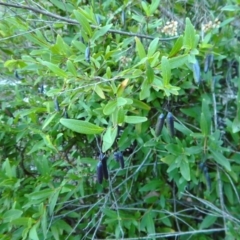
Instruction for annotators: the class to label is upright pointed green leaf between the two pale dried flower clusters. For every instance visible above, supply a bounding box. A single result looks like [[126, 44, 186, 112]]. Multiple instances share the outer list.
[[183, 18, 195, 50]]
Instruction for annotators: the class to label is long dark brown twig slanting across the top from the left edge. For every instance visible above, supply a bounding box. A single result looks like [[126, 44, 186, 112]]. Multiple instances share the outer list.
[[0, 2, 178, 41]]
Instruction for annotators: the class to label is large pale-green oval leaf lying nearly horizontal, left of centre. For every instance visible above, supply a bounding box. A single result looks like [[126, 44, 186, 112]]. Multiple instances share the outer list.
[[60, 118, 104, 134]]
